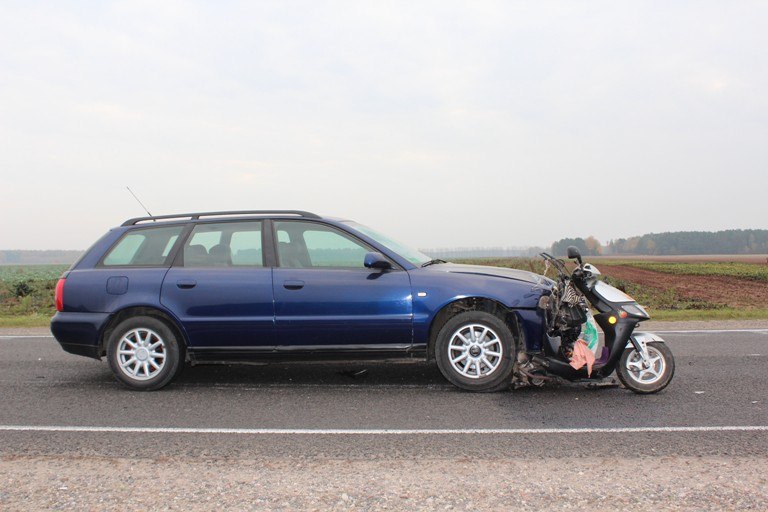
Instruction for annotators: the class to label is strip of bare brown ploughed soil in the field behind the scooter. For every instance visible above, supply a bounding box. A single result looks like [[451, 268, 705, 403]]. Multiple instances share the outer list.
[[599, 265, 768, 308]]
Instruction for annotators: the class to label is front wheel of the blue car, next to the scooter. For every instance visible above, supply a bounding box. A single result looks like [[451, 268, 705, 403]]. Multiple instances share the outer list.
[[435, 311, 516, 392]]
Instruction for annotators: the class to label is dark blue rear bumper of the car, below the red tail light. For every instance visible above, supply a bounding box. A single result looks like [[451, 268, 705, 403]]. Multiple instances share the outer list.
[[51, 312, 109, 359]]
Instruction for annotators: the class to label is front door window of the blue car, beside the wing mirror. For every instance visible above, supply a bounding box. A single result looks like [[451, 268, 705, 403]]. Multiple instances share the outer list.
[[275, 221, 371, 268]]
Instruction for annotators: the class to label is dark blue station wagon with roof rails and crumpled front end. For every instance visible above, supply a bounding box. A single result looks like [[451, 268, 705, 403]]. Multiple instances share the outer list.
[[51, 210, 553, 391]]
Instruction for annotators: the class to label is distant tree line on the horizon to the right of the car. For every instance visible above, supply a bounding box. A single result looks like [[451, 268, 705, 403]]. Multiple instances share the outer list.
[[552, 229, 768, 256]]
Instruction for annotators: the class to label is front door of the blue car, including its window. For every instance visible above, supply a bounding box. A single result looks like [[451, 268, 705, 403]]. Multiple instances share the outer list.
[[273, 220, 413, 351]]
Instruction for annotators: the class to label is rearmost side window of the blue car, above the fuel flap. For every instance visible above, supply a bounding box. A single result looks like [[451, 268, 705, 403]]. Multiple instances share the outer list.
[[101, 226, 183, 267]]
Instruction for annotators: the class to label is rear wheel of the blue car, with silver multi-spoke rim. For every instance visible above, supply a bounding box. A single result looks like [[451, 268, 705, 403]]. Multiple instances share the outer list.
[[107, 316, 184, 391]]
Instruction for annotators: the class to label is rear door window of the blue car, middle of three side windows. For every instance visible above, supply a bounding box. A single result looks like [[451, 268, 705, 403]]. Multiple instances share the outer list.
[[183, 221, 264, 267]]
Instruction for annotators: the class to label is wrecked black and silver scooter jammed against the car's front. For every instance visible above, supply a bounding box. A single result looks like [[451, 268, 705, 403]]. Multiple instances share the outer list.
[[515, 246, 675, 394]]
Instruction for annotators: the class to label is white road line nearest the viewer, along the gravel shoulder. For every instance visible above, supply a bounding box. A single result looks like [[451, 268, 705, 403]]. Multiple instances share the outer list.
[[0, 425, 768, 436]]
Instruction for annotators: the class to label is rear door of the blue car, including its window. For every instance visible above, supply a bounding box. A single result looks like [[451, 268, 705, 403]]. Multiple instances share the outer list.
[[160, 220, 275, 351]]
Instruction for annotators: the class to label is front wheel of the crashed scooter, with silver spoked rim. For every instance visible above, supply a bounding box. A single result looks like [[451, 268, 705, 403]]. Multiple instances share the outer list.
[[616, 341, 675, 395]]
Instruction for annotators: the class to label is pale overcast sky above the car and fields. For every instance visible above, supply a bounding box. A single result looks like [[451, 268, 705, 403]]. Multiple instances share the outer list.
[[0, 0, 768, 249]]
